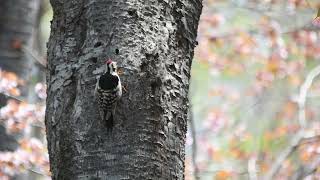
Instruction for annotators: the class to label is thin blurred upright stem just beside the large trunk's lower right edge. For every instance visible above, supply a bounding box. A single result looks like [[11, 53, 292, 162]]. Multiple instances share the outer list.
[[189, 107, 200, 180]]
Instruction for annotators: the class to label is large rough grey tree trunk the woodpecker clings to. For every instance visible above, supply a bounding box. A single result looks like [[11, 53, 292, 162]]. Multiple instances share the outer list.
[[46, 0, 202, 180]]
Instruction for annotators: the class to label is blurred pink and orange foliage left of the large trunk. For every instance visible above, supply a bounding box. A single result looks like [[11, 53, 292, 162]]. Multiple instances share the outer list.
[[0, 70, 50, 180]]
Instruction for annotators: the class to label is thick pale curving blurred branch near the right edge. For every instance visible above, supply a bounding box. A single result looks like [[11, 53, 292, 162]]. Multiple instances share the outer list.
[[265, 65, 320, 180]]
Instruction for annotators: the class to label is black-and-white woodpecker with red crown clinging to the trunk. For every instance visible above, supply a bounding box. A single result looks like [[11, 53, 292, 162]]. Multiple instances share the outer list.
[[94, 59, 122, 130]]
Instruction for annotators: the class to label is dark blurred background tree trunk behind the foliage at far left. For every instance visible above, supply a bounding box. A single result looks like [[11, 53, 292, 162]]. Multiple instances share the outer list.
[[0, 0, 40, 150]]
